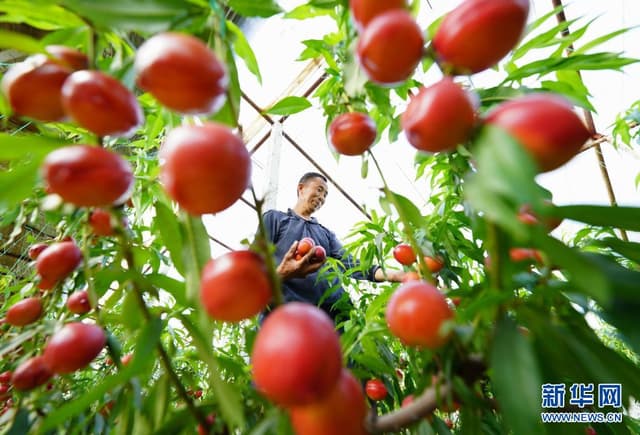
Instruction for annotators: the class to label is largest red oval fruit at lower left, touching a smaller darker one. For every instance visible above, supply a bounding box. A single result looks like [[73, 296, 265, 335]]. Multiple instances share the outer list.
[[43, 322, 107, 374]]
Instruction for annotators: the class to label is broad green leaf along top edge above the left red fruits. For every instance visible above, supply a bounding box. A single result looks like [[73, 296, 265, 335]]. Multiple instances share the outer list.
[[62, 0, 205, 33]]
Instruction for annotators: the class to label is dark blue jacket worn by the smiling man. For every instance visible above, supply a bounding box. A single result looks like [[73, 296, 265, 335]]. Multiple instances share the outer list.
[[263, 209, 378, 320]]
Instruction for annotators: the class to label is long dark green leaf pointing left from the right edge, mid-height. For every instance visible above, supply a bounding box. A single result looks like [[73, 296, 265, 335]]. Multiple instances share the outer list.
[[553, 205, 640, 231]]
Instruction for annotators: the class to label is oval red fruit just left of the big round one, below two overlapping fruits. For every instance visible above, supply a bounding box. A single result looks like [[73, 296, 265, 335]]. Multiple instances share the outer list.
[[42, 145, 134, 207]]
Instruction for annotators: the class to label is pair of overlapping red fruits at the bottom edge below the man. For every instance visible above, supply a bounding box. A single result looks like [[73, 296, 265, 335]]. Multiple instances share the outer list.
[[251, 302, 367, 435]]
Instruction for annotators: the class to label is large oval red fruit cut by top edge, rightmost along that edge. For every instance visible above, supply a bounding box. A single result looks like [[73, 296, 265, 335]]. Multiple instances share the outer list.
[[433, 0, 529, 74]]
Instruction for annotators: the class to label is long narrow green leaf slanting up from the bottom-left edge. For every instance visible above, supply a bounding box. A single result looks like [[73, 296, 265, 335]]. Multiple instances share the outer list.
[[40, 319, 162, 432]]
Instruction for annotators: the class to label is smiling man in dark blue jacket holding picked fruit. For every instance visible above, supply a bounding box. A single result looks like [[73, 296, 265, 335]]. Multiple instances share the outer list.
[[264, 172, 404, 323]]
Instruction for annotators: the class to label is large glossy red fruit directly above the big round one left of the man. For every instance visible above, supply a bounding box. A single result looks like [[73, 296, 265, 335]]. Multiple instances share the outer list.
[[134, 32, 229, 114]]
